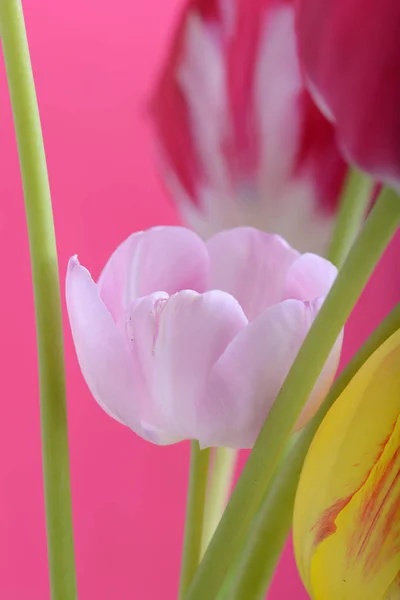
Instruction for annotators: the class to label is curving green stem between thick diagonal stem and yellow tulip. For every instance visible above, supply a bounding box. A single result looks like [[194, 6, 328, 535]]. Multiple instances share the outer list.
[[229, 304, 400, 600]]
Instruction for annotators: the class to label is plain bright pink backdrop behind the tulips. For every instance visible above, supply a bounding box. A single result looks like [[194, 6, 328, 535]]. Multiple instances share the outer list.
[[0, 0, 400, 600]]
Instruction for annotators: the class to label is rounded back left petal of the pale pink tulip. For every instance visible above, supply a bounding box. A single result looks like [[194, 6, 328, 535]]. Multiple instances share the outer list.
[[99, 227, 208, 320]]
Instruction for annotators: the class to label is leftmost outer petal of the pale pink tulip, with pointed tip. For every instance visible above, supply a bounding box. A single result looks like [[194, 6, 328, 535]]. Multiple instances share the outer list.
[[66, 257, 143, 435]]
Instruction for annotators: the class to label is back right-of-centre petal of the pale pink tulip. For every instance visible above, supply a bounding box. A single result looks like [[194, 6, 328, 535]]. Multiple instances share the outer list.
[[207, 227, 300, 321]]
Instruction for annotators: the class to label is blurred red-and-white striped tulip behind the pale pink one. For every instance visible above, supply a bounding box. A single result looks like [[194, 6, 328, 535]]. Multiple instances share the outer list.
[[152, 0, 346, 253]]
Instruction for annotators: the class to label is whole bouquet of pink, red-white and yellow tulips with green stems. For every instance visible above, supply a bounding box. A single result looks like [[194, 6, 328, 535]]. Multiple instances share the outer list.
[[0, 0, 400, 600]]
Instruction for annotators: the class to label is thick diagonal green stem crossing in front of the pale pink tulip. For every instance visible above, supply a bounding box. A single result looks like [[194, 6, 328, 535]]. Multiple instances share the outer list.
[[187, 190, 400, 600]]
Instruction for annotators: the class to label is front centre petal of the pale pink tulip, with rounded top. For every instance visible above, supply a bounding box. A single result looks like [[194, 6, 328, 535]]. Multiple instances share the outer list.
[[153, 291, 247, 439]]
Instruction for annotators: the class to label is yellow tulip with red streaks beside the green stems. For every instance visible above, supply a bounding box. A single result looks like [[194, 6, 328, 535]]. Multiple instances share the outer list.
[[294, 331, 400, 600]]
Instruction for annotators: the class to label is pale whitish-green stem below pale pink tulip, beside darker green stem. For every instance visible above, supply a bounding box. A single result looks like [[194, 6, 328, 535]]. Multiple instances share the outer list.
[[201, 448, 238, 556]]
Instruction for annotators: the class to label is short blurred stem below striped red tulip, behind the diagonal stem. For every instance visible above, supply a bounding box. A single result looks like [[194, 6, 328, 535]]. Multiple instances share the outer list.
[[328, 169, 376, 267]]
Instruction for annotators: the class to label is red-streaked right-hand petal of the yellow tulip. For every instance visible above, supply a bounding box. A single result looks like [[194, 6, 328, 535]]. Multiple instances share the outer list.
[[311, 419, 400, 600]]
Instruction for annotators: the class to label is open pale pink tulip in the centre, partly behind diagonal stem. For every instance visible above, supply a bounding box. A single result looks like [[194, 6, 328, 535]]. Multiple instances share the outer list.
[[66, 227, 341, 448]]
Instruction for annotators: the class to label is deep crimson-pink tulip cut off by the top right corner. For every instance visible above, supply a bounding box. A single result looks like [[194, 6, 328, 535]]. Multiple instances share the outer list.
[[298, 0, 400, 188]]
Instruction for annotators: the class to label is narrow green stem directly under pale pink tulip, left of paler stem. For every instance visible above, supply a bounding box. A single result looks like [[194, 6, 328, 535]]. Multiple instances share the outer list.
[[179, 441, 210, 599]]
